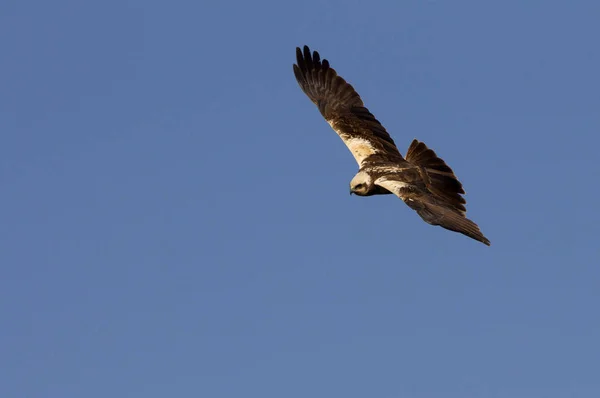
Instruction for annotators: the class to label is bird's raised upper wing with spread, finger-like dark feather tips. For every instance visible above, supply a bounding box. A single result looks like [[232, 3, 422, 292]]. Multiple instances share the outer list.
[[294, 46, 403, 167]]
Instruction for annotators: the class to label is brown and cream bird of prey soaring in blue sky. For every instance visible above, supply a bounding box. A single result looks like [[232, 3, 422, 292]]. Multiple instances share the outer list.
[[293, 46, 491, 246]]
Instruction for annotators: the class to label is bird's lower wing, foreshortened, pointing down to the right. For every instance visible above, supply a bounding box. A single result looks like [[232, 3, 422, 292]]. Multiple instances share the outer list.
[[375, 175, 490, 246]]
